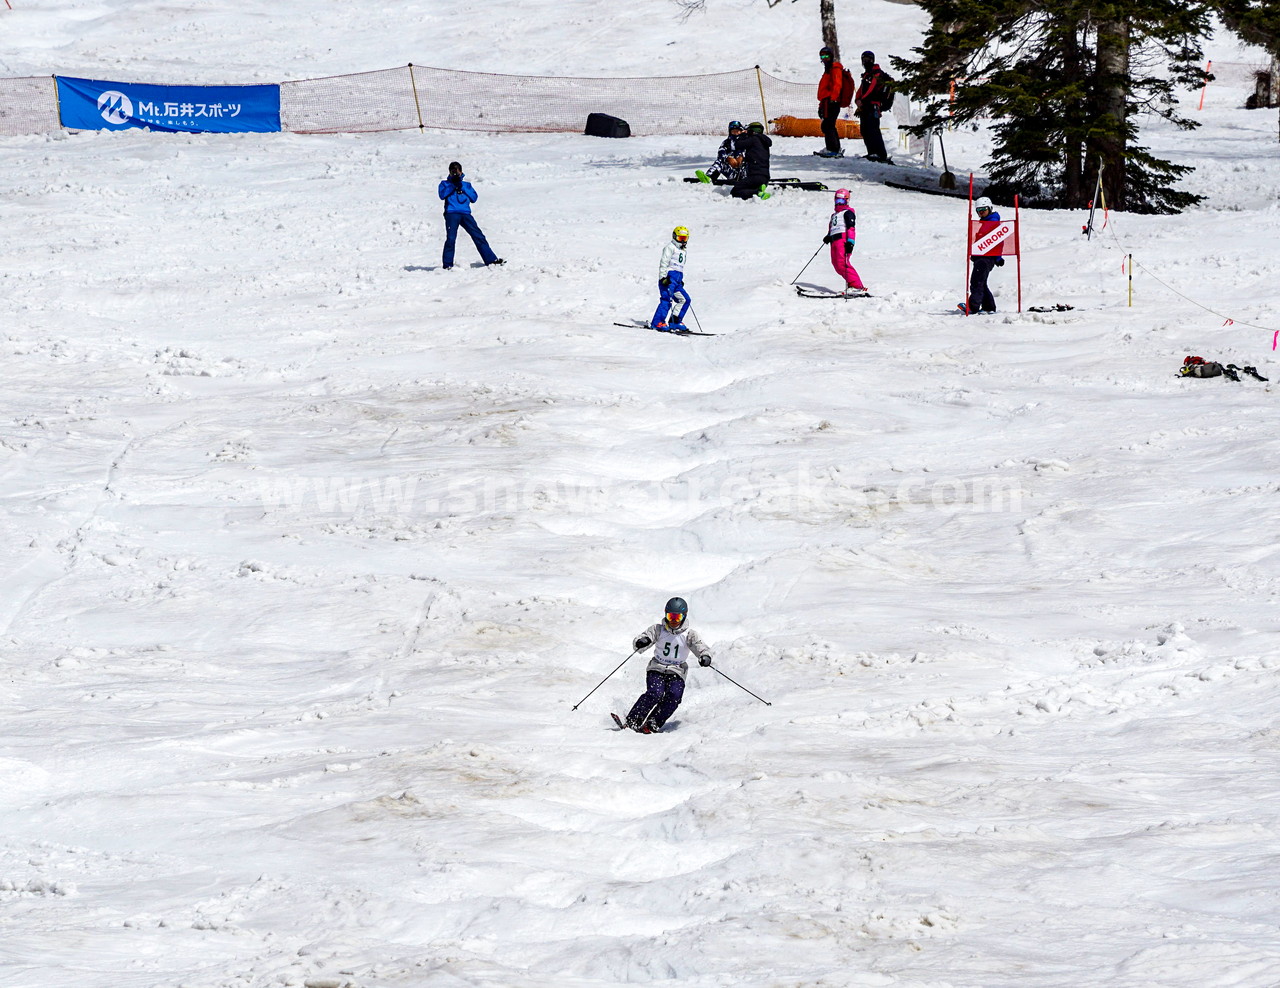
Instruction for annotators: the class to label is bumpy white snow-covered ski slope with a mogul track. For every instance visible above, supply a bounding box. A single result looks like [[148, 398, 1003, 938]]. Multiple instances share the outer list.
[[0, 0, 1280, 988]]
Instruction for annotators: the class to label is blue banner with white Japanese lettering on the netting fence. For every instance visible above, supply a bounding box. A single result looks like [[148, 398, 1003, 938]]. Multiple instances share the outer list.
[[56, 76, 280, 133]]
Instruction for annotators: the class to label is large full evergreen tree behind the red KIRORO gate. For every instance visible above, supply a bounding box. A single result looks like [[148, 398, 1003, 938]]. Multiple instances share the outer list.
[[893, 0, 1208, 212]]
